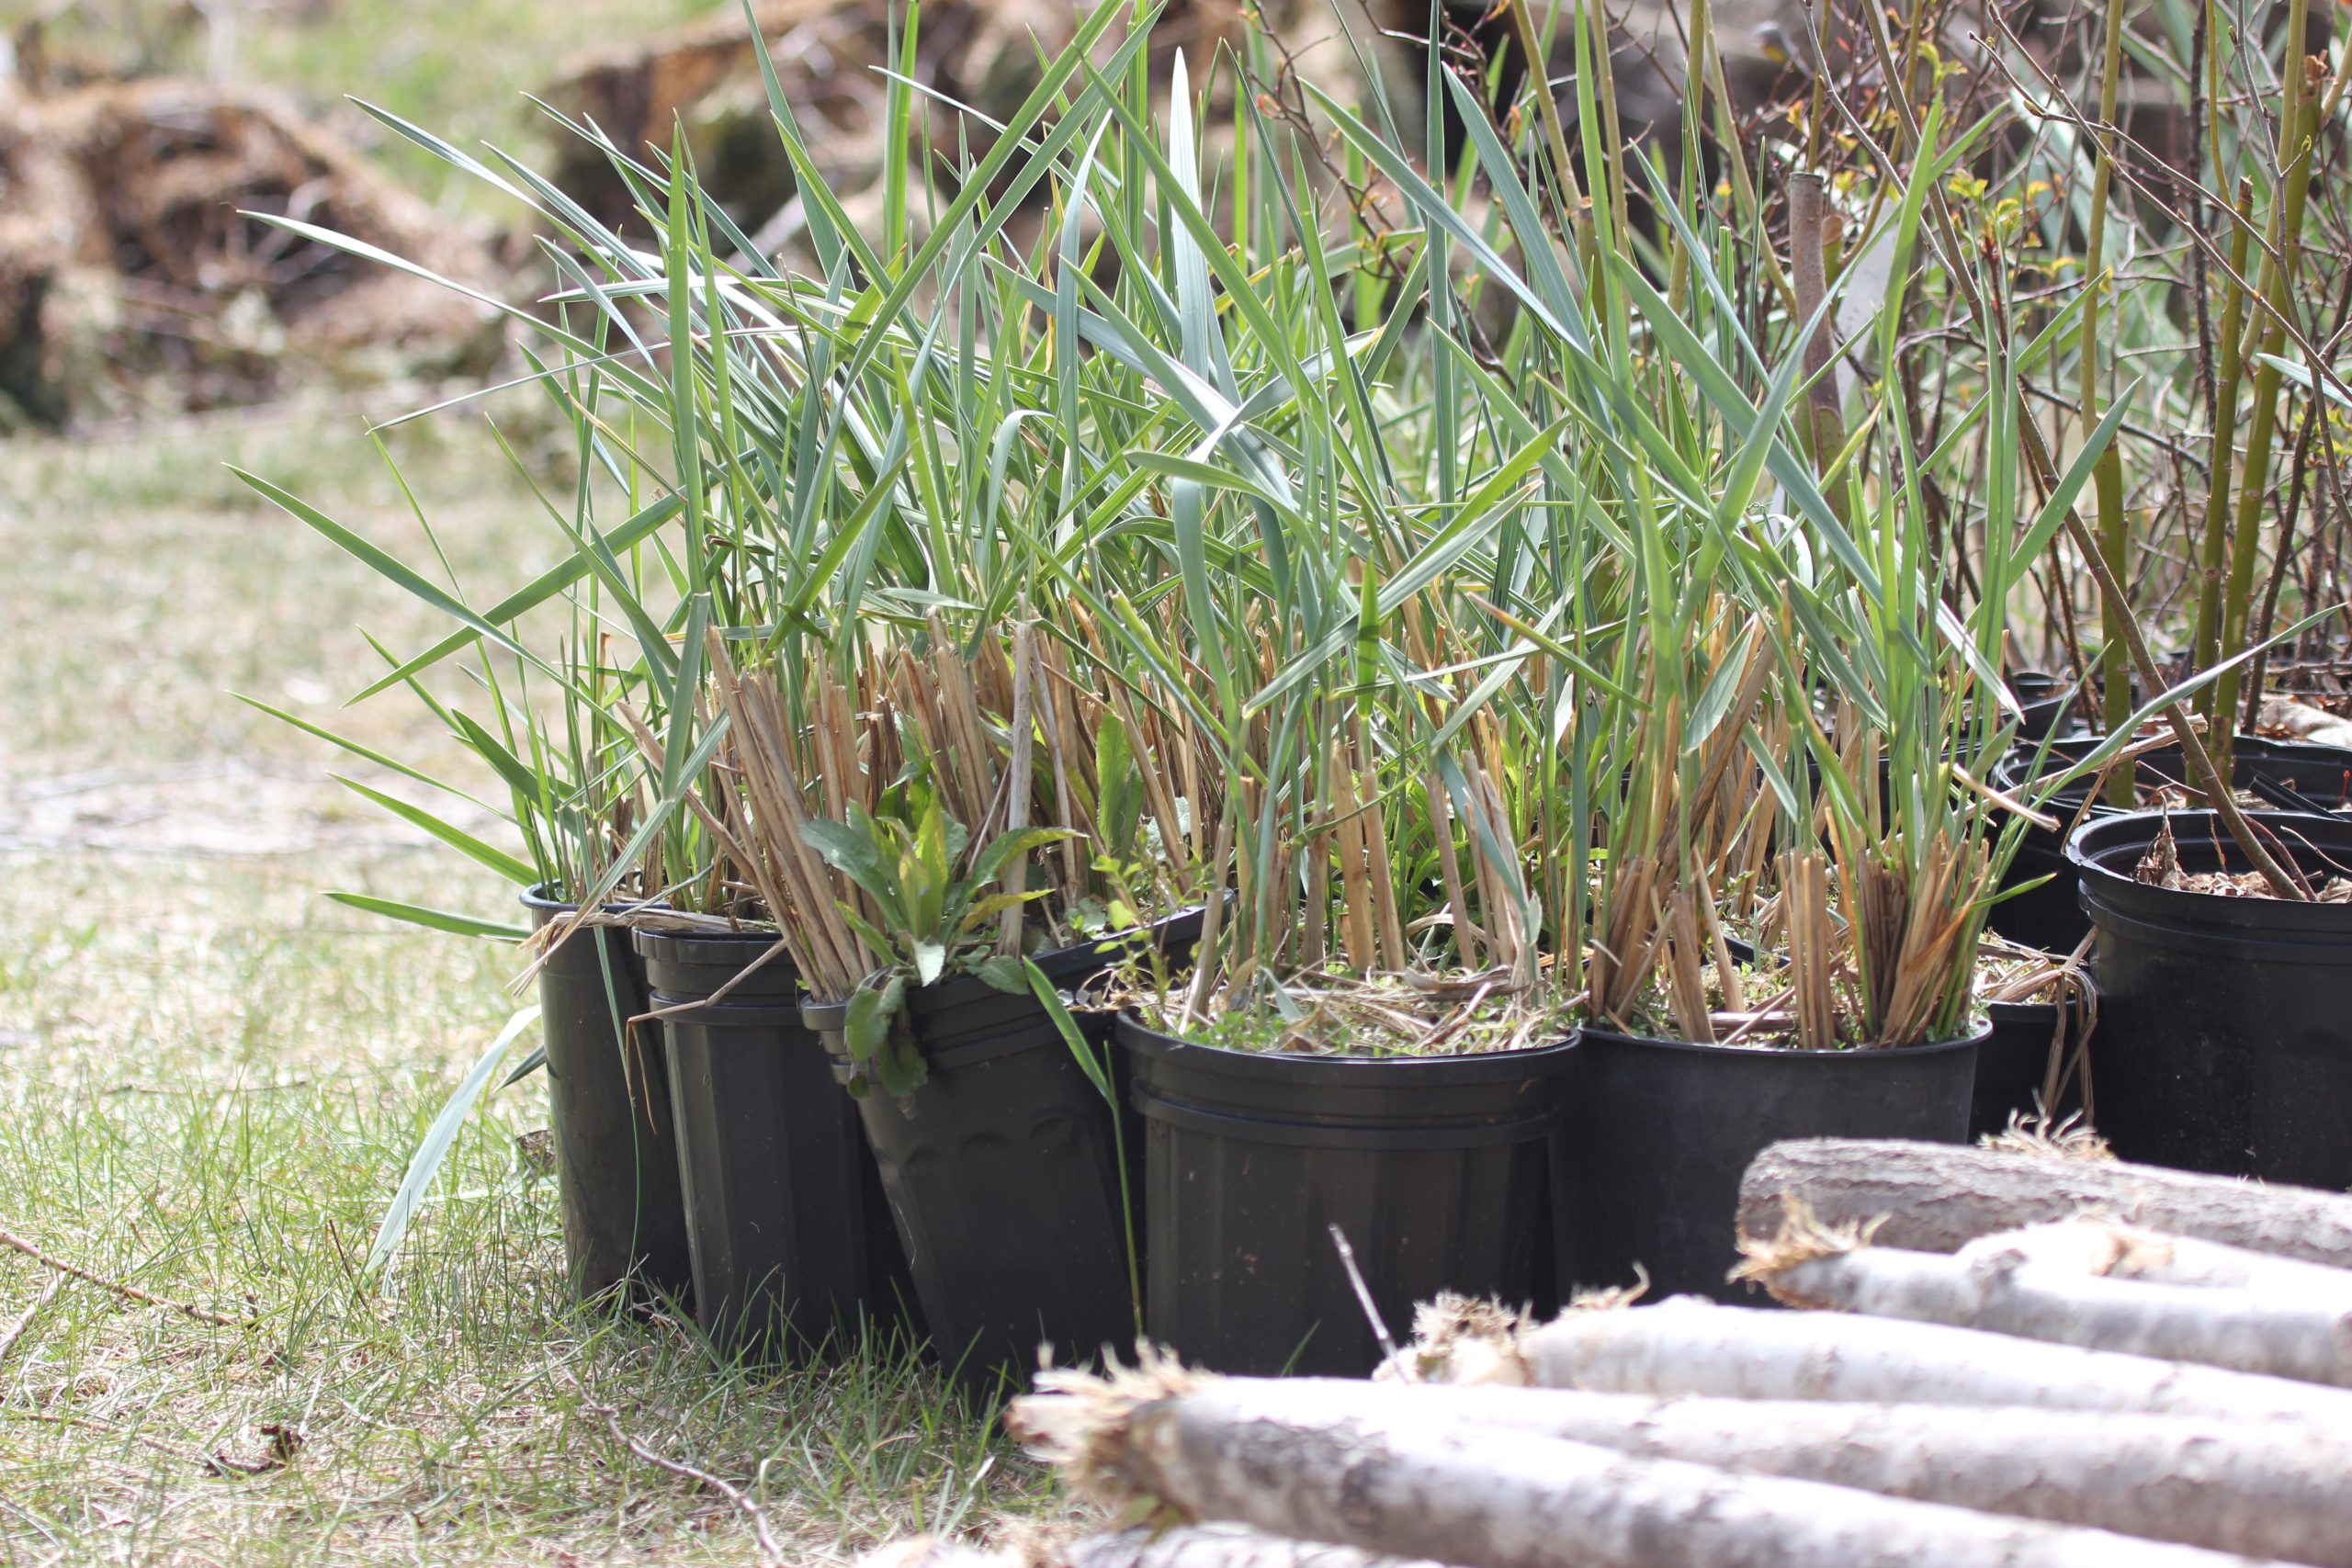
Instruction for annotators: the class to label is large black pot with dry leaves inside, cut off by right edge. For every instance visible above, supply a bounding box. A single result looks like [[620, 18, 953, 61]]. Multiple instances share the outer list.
[[2067, 811, 2352, 1192]]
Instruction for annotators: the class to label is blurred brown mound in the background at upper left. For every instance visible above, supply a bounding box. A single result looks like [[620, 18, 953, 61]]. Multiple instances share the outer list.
[[0, 77, 501, 428]]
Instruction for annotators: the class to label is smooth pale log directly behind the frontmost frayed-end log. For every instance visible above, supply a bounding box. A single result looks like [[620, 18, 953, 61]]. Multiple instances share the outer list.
[[1185, 1382, 2352, 1568]]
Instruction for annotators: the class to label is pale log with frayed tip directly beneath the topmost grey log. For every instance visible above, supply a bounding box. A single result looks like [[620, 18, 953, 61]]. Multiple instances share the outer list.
[[1750, 1246, 2352, 1387]]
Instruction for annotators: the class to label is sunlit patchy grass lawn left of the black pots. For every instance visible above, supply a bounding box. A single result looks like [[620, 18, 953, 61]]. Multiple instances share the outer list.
[[0, 400, 1061, 1563]]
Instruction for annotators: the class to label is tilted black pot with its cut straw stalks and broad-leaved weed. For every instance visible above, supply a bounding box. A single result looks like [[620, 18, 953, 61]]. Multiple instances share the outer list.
[[718, 621, 1166, 1387]]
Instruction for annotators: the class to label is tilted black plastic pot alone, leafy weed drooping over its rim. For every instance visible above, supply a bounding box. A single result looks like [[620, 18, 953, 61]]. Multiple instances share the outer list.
[[802, 919, 1157, 1389]]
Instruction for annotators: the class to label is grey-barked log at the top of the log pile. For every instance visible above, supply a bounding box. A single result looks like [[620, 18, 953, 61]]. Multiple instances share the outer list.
[[1740, 1138, 2352, 1269]]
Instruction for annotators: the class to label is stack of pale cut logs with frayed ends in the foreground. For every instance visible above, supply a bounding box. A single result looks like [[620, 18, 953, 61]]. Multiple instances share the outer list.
[[868, 1138, 2352, 1568]]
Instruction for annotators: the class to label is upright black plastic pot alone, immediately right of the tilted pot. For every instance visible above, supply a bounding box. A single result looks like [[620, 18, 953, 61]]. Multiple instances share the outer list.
[[1117, 1016, 1574, 1378]]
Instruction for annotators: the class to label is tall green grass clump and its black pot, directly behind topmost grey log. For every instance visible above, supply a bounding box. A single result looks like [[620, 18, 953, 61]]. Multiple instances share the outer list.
[[1345, 49, 2112, 1295]]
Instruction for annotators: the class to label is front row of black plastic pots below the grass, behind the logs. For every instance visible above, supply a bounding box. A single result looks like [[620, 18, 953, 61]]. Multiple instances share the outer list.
[[529, 893, 2098, 1384]]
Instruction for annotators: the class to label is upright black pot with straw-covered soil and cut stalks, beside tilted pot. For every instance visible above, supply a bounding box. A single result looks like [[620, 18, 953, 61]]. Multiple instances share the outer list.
[[1120, 662, 1571, 1375]]
